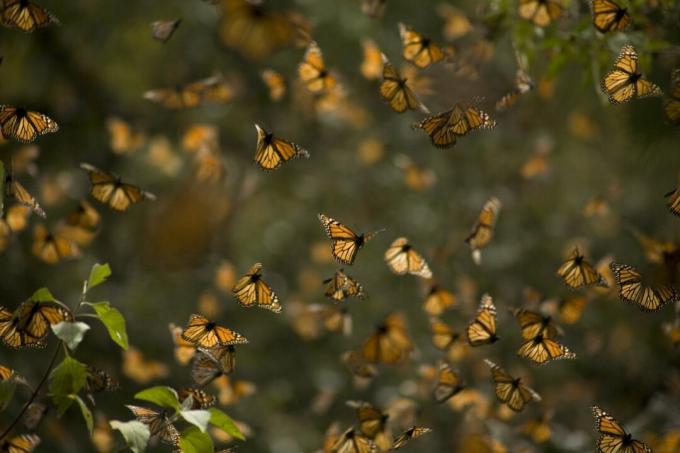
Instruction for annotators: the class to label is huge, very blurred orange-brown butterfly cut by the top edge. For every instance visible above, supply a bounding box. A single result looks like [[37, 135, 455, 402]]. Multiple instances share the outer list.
[[219, 0, 295, 59]]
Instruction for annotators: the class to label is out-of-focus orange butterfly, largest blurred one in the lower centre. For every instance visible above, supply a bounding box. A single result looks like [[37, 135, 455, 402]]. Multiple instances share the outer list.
[[361, 313, 413, 364]]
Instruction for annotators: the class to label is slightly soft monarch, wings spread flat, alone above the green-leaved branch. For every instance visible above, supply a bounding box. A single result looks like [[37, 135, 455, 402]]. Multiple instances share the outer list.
[[80, 163, 156, 212]]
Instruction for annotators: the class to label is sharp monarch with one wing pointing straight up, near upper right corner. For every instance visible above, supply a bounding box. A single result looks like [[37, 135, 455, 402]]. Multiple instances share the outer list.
[[602, 45, 663, 104]]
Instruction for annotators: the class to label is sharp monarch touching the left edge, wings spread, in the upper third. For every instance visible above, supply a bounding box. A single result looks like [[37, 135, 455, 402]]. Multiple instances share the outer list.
[[0, 104, 59, 143]]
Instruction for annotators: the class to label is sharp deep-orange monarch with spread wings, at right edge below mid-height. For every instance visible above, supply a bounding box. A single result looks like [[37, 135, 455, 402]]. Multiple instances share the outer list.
[[609, 262, 680, 311]]
